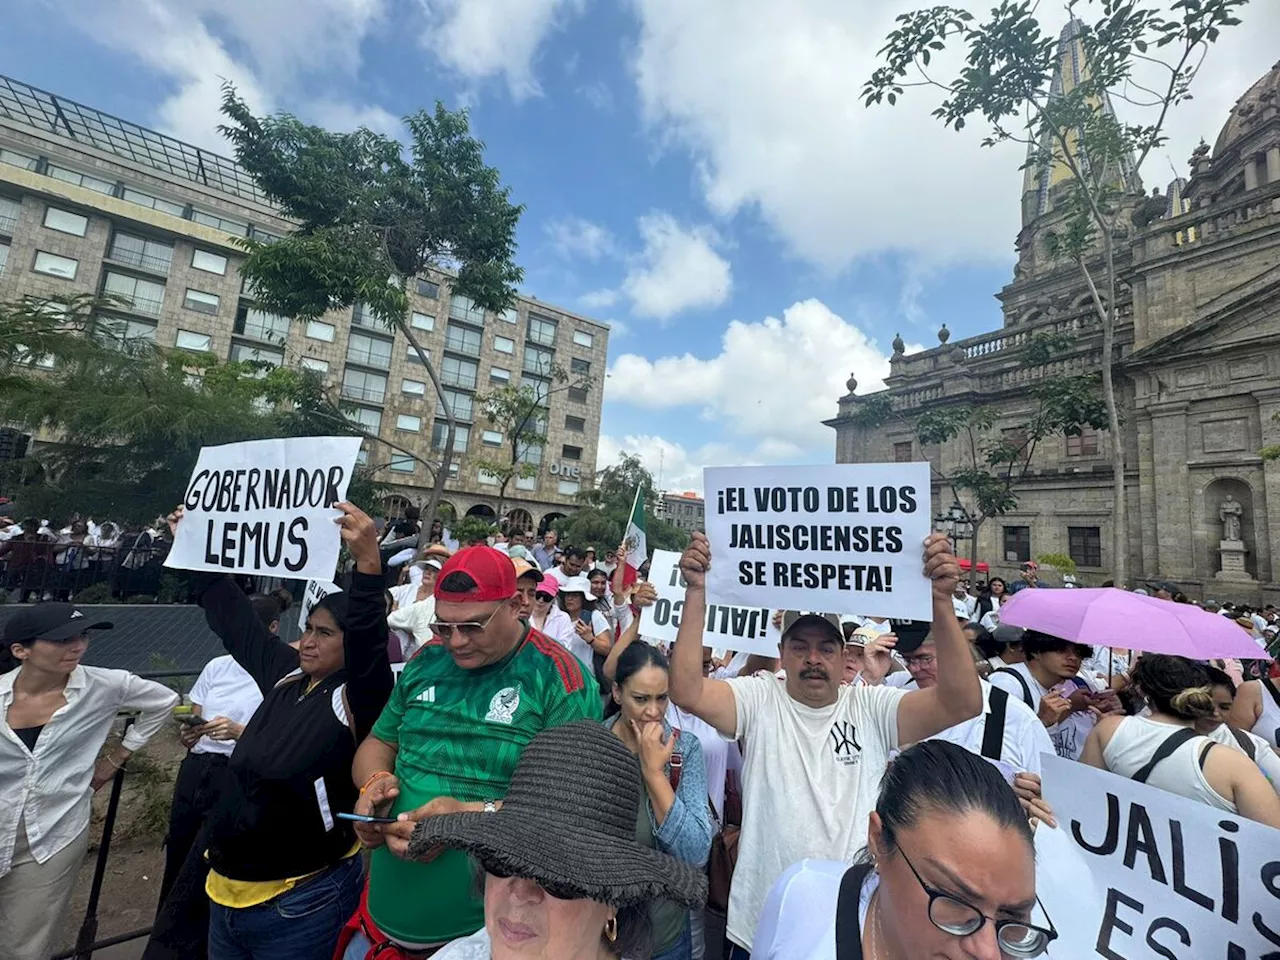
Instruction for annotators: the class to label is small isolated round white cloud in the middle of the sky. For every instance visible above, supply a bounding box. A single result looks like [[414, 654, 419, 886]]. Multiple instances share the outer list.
[[622, 212, 733, 320]]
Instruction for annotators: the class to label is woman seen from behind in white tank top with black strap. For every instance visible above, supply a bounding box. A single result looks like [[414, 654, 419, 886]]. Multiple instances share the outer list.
[[1080, 653, 1280, 828]]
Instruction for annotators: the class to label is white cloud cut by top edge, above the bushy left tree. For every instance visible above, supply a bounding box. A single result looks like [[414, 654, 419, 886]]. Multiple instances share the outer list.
[[419, 0, 585, 100]]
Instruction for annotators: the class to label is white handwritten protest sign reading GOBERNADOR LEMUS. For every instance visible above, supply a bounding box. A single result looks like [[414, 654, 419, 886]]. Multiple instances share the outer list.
[[165, 436, 361, 580]]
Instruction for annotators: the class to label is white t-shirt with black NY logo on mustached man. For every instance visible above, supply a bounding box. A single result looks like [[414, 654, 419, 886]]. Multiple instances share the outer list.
[[724, 675, 906, 950]]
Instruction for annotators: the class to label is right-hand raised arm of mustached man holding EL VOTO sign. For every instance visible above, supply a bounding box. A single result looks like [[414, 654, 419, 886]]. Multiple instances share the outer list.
[[897, 534, 982, 744]]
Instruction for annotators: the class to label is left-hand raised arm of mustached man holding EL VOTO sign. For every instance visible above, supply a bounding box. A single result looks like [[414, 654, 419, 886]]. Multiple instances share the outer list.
[[671, 532, 737, 737]]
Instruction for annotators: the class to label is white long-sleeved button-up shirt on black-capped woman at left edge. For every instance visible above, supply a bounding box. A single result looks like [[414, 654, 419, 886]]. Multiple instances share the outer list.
[[0, 667, 178, 877]]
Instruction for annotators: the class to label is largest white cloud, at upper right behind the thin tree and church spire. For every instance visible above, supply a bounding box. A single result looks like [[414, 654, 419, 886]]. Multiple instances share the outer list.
[[632, 0, 1280, 269]]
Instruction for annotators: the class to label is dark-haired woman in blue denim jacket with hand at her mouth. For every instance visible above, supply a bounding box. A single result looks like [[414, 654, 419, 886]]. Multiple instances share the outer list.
[[604, 642, 712, 960]]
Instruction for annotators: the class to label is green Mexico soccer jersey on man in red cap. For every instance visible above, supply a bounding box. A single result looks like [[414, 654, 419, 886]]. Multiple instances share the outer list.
[[369, 628, 600, 945]]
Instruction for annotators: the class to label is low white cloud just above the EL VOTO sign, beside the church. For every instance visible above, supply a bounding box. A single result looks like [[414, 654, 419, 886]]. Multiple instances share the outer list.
[[605, 300, 906, 461]]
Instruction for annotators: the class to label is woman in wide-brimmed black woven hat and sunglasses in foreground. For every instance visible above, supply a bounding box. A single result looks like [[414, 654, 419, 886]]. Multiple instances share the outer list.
[[410, 721, 707, 960]]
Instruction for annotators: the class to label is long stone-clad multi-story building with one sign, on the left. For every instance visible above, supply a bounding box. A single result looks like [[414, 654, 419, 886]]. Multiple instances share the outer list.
[[0, 77, 609, 542]]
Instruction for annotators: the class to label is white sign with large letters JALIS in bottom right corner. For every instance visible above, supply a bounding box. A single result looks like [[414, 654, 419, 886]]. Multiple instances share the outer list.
[[1037, 757, 1280, 960]]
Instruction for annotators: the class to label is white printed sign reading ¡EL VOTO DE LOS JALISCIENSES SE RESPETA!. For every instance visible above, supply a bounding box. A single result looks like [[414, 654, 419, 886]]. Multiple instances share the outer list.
[[704, 463, 933, 620]]
